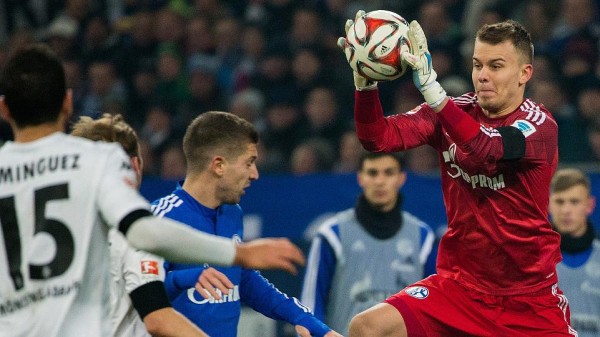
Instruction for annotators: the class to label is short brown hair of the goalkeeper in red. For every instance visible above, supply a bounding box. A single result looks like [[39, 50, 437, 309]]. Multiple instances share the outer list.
[[475, 20, 533, 63]]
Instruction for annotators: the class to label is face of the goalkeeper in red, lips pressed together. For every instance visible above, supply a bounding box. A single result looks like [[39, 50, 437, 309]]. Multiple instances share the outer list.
[[471, 40, 533, 117]]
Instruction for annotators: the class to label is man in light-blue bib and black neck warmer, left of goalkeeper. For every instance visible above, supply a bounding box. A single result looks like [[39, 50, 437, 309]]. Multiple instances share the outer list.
[[301, 152, 437, 335]]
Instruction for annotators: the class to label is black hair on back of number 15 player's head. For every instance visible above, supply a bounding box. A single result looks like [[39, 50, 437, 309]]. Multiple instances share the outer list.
[[0, 44, 67, 128]]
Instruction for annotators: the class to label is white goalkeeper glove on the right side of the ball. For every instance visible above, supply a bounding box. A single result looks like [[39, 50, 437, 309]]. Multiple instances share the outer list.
[[401, 20, 447, 108]]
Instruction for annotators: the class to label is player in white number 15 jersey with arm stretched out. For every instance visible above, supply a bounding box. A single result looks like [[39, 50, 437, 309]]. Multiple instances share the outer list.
[[0, 45, 303, 337]]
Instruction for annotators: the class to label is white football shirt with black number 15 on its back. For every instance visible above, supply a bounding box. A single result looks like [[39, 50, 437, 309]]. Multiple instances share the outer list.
[[0, 132, 149, 337]]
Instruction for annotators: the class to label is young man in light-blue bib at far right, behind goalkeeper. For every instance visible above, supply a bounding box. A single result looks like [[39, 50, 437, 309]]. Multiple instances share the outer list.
[[549, 168, 600, 337]]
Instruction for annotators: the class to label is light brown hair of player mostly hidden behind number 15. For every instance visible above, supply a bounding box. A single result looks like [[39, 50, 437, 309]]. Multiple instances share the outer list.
[[71, 113, 140, 158]]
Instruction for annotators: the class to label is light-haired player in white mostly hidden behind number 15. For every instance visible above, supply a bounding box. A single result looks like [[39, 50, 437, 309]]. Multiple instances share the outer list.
[[71, 114, 218, 337]]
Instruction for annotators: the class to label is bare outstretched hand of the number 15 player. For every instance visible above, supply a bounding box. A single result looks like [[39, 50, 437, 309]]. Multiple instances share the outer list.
[[234, 238, 305, 275]]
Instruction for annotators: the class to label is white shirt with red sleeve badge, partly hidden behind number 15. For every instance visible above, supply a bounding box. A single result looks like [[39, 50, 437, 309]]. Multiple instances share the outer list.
[[108, 229, 165, 337]]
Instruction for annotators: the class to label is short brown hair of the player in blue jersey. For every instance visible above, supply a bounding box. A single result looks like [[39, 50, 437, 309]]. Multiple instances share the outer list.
[[183, 111, 258, 172]]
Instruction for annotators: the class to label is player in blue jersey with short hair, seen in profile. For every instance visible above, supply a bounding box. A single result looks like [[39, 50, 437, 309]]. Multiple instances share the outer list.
[[152, 111, 341, 337]]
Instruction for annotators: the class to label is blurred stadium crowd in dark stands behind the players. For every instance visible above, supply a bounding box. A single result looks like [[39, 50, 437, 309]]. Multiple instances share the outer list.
[[0, 0, 600, 179]]
